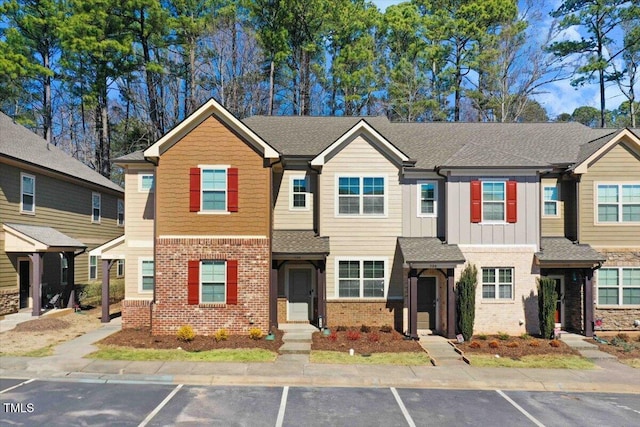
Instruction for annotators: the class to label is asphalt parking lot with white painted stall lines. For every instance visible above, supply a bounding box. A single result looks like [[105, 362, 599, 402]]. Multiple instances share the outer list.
[[0, 378, 640, 427]]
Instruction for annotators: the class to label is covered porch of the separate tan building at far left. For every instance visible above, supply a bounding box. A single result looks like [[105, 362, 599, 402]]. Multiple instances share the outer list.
[[2, 223, 87, 316]]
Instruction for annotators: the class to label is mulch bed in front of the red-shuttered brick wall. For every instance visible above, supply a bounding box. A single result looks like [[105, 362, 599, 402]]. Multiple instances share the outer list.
[[98, 329, 283, 352]]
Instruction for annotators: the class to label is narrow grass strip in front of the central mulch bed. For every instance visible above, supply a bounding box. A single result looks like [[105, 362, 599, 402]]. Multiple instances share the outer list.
[[310, 350, 431, 366]]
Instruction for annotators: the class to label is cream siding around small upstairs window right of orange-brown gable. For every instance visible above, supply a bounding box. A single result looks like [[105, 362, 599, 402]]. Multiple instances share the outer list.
[[273, 169, 317, 230]]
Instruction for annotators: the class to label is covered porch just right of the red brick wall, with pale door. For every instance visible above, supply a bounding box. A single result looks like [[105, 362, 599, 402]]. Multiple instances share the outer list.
[[269, 230, 329, 328]]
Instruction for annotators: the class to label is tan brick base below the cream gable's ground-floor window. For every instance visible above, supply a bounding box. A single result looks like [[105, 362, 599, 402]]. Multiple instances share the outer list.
[[327, 300, 403, 331]]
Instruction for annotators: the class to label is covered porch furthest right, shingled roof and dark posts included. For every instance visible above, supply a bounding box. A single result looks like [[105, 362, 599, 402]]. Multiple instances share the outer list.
[[535, 237, 605, 337]]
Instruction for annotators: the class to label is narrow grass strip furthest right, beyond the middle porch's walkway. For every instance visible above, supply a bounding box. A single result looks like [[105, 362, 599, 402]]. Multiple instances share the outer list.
[[467, 354, 595, 369]]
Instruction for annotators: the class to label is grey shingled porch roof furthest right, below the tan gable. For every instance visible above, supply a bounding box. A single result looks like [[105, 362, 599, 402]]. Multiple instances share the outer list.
[[535, 237, 606, 267]]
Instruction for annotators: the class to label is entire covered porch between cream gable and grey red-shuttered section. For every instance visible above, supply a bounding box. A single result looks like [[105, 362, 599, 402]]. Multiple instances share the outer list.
[[398, 237, 465, 339]]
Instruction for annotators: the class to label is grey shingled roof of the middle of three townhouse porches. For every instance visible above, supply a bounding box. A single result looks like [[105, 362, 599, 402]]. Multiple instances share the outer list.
[[398, 237, 465, 268]]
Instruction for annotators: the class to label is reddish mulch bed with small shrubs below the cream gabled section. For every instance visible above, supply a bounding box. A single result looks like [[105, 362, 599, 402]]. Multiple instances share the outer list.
[[311, 328, 424, 354]]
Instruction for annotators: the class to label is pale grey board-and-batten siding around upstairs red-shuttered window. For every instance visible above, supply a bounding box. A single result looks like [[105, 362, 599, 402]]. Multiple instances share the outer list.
[[447, 175, 540, 246]]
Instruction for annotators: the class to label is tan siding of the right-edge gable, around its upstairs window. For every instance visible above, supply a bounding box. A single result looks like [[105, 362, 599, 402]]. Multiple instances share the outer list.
[[579, 142, 640, 247]]
